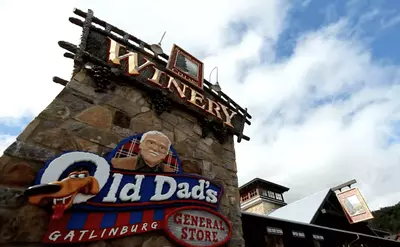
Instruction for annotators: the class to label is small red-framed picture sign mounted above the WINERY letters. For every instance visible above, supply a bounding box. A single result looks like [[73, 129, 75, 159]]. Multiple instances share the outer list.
[[167, 44, 204, 90]]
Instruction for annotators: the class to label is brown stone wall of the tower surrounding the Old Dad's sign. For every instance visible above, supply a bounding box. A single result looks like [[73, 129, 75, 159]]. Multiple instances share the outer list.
[[0, 70, 244, 247]]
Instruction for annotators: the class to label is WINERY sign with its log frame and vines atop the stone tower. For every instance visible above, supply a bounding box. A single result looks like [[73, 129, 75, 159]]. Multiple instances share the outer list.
[[59, 9, 251, 143]]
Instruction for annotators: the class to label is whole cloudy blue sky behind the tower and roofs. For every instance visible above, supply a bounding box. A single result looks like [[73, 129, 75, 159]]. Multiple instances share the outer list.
[[0, 0, 400, 210]]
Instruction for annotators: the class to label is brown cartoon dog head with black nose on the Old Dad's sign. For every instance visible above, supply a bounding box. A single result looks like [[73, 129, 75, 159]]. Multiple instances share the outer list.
[[25, 171, 99, 219]]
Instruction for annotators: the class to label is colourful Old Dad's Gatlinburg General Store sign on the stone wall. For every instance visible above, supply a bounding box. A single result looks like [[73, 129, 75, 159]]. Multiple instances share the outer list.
[[25, 131, 231, 246]]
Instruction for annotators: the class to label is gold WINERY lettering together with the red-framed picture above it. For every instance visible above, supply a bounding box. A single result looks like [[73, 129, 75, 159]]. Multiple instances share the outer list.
[[107, 38, 237, 128]]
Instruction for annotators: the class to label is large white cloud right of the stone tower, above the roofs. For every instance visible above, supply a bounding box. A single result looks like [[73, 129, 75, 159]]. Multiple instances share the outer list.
[[237, 21, 400, 209]]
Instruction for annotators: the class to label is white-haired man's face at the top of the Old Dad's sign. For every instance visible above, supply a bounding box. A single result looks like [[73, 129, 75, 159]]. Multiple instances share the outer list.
[[139, 132, 171, 167]]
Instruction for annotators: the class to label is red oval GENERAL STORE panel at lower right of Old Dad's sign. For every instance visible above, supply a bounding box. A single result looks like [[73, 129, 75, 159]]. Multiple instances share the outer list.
[[163, 206, 232, 247]]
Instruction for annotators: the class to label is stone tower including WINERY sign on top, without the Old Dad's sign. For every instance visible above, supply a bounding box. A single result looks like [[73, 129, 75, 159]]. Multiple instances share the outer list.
[[0, 9, 251, 247]]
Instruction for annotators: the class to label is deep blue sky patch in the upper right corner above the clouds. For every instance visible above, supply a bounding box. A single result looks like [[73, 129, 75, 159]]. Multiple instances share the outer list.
[[276, 0, 400, 63]]
